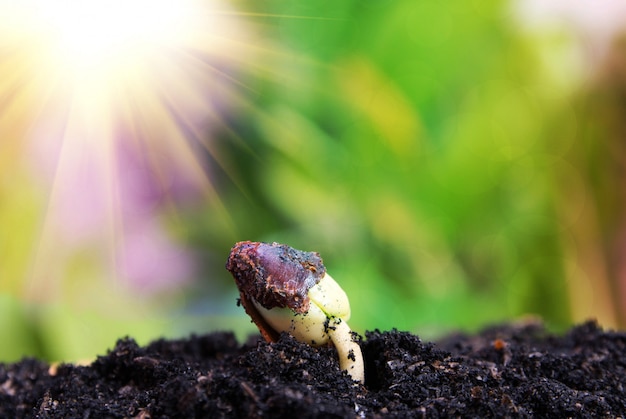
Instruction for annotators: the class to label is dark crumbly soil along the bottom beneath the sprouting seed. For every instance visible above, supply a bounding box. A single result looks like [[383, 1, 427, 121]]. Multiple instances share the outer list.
[[0, 322, 626, 419]]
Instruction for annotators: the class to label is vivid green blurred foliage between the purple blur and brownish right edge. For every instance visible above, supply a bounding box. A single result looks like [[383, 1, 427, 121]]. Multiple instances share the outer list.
[[192, 1, 571, 335]]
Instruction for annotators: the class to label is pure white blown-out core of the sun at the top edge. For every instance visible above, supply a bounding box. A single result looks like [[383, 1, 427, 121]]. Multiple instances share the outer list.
[[39, 0, 205, 74]]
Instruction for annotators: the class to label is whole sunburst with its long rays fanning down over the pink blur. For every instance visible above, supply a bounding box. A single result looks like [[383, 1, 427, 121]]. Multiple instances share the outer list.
[[0, 0, 252, 292]]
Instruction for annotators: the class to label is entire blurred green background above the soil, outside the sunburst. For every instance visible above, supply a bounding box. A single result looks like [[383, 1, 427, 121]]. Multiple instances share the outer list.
[[0, 0, 626, 361]]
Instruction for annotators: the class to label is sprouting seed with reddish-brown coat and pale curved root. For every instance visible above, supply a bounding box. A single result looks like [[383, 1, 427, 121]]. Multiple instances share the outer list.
[[226, 241, 365, 383]]
